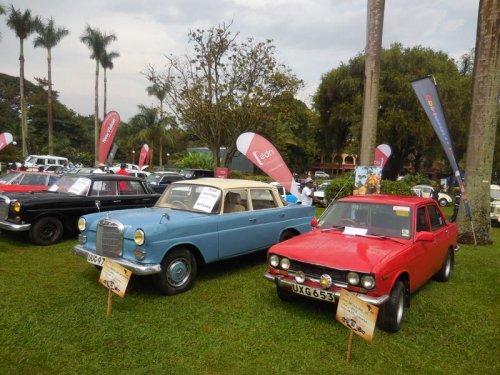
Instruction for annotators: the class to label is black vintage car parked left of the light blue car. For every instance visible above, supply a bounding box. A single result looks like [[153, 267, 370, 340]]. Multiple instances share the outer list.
[[0, 174, 160, 245]]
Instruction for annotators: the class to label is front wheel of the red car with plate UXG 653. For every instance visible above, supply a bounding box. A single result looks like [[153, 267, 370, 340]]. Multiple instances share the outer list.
[[378, 280, 408, 332]]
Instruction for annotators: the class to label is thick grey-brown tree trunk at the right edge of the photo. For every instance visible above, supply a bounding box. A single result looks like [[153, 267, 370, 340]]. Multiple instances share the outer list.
[[458, 0, 500, 244]]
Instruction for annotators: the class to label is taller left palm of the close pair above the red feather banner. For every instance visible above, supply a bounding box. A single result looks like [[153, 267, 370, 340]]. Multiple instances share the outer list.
[[80, 25, 116, 165]]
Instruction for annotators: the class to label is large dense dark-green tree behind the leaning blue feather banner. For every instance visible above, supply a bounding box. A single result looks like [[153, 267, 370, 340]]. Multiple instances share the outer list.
[[314, 43, 470, 178]]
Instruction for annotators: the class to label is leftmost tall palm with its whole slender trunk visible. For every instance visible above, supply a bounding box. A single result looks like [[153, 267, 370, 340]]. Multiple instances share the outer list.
[[7, 5, 40, 157]]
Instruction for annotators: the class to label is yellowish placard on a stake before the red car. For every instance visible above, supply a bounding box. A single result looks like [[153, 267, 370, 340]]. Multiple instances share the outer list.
[[336, 289, 378, 342]]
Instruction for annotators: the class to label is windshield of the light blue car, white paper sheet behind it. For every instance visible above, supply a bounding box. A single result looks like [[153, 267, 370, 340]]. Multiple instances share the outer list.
[[156, 184, 222, 213]]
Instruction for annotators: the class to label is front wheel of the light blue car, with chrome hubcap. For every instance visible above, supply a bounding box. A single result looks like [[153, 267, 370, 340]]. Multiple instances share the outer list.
[[154, 248, 197, 296]]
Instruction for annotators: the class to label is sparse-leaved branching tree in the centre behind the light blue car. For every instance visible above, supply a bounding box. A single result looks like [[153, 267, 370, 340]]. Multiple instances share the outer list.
[[150, 24, 302, 166]]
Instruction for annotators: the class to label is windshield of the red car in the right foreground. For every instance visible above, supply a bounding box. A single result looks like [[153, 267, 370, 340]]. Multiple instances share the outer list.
[[318, 201, 412, 239]]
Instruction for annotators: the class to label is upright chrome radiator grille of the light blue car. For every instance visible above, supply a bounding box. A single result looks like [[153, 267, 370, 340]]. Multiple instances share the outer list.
[[96, 219, 123, 257]]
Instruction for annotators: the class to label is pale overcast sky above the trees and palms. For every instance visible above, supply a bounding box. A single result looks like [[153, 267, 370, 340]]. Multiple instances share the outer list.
[[0, 0, 479, 122]]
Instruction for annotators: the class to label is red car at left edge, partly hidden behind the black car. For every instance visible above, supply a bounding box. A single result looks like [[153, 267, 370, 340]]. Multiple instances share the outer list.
[[0, 171, 60, 193]]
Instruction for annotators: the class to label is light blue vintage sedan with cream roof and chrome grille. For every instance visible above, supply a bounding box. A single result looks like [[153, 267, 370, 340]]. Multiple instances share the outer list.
[[73, 178, 314, 295]]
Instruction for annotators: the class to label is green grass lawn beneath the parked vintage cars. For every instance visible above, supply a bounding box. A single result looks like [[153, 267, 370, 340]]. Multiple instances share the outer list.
[[0, 209, 500, 375]]
